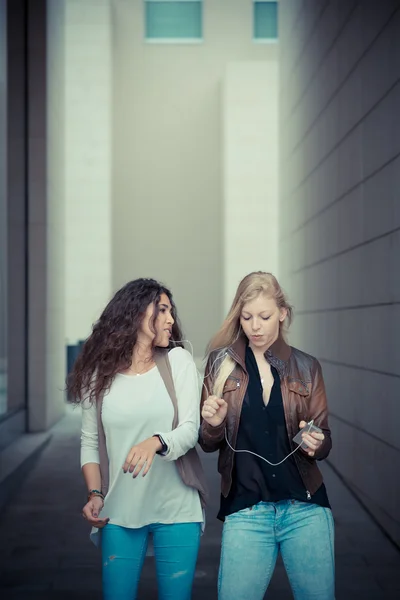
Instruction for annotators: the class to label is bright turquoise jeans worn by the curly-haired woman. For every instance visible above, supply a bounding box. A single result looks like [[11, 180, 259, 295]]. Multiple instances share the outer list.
[[101, 523, 201, 600]]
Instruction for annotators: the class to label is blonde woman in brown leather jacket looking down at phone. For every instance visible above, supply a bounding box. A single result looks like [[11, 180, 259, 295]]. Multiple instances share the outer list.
[[200, 272, 335, 600]]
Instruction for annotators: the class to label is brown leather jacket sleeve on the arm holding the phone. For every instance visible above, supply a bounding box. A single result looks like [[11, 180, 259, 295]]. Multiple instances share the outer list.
[[309, 359, 332, 460]]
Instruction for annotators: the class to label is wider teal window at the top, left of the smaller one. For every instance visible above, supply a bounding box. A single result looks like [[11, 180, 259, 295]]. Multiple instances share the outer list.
[[145, 0, 203, 42]]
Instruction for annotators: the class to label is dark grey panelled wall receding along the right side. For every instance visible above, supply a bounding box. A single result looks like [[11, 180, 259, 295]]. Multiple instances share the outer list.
[[280, 0, 400, 543]]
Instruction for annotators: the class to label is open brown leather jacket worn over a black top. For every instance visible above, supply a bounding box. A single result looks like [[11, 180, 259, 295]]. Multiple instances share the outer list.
[[199, 337, 332, 497]]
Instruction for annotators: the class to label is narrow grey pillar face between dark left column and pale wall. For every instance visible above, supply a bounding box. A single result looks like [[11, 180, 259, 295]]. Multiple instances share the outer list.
[[46, 2, 67, 424]]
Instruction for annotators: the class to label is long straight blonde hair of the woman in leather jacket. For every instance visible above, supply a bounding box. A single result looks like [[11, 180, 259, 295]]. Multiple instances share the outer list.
[[207, 271, 293, 397]]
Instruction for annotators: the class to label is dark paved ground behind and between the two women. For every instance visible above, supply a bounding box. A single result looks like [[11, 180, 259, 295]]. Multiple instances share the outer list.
[[0, 413, 400, 600]]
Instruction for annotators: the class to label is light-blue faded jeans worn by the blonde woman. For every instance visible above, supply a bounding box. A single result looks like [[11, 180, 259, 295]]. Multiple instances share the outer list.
[[218, 500, 335, 600]]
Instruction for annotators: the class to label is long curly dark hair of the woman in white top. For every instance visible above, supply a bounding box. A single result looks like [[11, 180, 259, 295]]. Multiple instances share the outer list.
[[67, 279, 183, 404]]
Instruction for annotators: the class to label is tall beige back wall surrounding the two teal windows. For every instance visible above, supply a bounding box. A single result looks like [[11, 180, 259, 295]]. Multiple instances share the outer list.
[[112, 0, 277, 355]]
